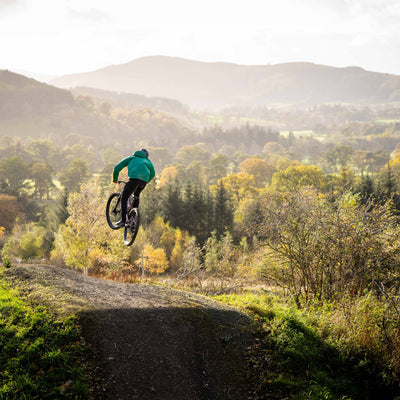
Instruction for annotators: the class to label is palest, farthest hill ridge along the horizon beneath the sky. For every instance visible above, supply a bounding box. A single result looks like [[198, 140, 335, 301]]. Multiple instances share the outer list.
[[52, 56, 400, 108]]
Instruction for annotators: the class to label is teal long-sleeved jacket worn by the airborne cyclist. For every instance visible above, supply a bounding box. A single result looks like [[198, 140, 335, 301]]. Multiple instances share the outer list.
[[113, 151, 155, 182]]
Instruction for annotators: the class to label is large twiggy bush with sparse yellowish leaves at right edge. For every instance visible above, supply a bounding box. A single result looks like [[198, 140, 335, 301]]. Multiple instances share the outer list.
[[263, 189, 400, 304]]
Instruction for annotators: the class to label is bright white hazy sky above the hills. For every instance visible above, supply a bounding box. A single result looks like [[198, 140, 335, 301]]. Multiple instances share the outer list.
[[0, 0, 400, 75]]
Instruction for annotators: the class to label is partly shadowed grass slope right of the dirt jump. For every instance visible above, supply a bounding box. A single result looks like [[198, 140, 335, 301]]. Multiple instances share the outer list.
[[216, 293, 398, 400]]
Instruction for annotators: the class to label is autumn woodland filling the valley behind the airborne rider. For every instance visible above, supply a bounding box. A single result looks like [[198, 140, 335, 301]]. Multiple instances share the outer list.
[[0, 79, 400, 399]]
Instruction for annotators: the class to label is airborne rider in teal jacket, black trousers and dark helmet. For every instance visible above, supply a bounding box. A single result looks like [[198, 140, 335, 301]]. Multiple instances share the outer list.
[[113, 149, 155, 228]]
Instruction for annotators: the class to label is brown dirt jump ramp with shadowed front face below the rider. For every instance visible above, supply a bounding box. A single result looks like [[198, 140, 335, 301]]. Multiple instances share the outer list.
[[4, 266, 256, 400]]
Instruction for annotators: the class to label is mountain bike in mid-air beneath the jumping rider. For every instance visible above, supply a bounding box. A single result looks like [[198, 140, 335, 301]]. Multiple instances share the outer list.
[[106, 181, 140, 246]]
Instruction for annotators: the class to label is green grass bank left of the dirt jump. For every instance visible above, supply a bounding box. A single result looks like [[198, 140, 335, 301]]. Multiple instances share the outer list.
[[0, 280, 88, 400]]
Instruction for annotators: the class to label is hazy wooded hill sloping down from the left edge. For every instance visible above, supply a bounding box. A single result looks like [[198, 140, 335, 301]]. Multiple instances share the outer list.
[[0, 70, 193, 151]]
